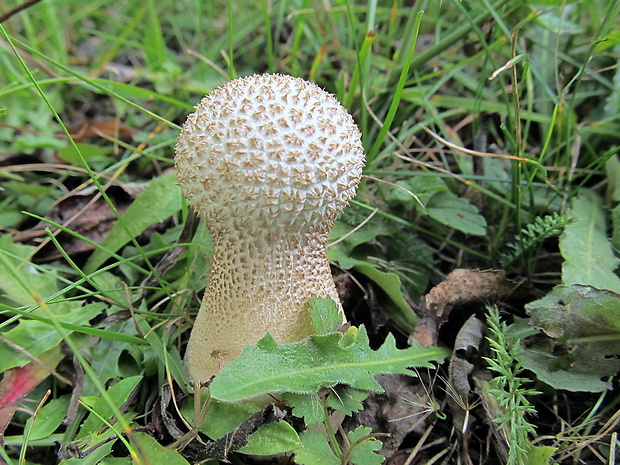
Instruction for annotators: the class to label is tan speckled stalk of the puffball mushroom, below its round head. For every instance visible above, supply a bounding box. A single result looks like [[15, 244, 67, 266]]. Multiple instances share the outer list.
[[185, 224, 340, 378]]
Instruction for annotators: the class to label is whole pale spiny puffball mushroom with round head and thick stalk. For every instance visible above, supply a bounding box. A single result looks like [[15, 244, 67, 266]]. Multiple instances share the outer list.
[[175, 74, 364, 382]]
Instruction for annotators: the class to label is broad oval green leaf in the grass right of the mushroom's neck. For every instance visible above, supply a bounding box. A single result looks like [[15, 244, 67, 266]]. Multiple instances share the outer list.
[[424, 192, 487, 236]]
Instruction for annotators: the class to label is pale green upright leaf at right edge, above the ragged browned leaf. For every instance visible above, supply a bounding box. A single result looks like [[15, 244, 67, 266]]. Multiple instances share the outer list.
[[560, 189, 620, 292]]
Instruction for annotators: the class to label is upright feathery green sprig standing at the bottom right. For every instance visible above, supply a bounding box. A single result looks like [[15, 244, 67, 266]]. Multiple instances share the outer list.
[[485, 307, 539, 465]]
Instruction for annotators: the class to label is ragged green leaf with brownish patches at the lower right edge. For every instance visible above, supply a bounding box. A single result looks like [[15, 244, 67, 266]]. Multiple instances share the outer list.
[[519, 285, 620, 392]]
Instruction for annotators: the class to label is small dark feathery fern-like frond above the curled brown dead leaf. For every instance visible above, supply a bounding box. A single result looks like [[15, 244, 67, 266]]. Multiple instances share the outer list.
[[500, 212, 573, 268]]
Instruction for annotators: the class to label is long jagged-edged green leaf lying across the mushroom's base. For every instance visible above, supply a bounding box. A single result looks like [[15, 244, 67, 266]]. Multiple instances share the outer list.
[[210, 326, 449, 402]]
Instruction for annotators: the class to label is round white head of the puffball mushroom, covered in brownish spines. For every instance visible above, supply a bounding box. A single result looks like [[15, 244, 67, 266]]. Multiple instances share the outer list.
[[175, 74, 364, 234]]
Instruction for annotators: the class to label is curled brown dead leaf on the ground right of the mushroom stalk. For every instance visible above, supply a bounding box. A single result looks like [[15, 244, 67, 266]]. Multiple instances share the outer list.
[[409, 268, 518, 347]]
